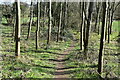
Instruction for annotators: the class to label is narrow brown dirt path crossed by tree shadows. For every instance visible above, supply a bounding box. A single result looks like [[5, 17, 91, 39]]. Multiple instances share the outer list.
[[55, 43, 74, 80]]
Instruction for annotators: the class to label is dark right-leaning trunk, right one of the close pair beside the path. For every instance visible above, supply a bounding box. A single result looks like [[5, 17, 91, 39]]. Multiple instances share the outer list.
[[84, 2, 94, 58]]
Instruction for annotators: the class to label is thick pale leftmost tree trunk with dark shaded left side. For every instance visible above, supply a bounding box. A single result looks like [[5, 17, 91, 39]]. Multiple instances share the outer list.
[[15, 0, 20, 56]]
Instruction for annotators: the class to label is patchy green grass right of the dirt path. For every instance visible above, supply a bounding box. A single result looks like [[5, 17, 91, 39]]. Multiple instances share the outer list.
[[63, 22, 120, 80]]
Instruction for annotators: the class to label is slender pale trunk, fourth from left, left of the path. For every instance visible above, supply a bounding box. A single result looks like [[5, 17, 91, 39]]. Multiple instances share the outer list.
[[47, 0, 52, 45]]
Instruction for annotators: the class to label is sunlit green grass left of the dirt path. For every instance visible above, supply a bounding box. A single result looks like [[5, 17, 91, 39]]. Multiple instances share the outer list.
[[0, 25, 70, 78]]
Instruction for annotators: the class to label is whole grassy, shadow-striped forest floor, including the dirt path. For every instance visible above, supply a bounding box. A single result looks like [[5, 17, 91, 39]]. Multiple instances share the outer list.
[[0, 20, 120, 79]]
